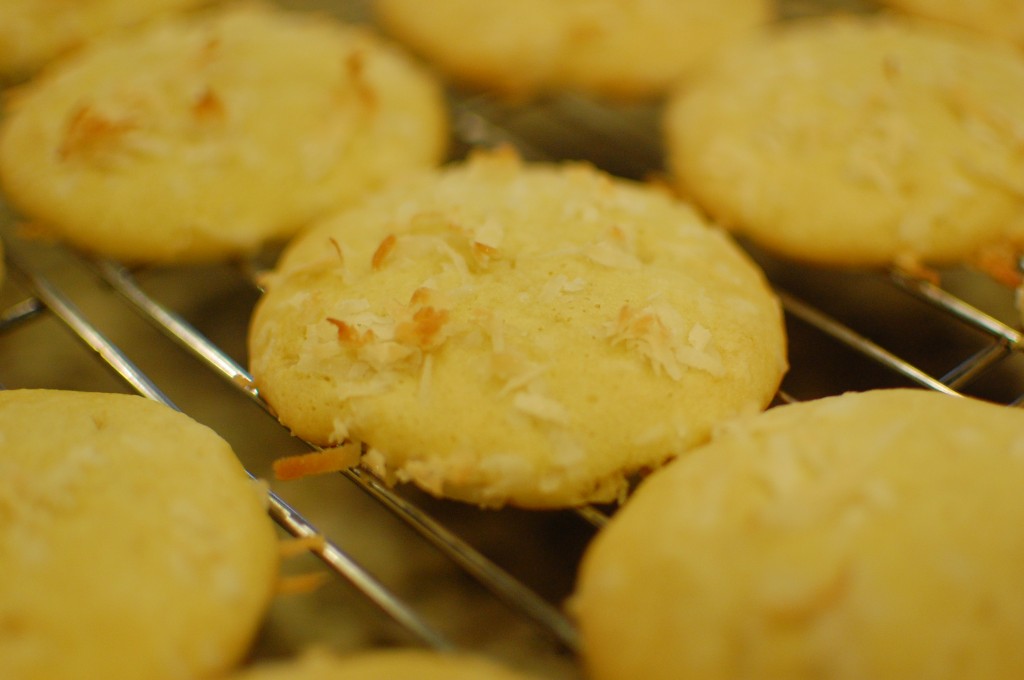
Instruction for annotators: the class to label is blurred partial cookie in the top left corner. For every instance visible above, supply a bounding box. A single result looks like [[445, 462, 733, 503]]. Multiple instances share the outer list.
[[0, 0, 206, 78]]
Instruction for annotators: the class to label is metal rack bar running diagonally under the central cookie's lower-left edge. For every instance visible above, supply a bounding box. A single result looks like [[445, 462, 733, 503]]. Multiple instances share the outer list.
[[95, 256, 579, 650]]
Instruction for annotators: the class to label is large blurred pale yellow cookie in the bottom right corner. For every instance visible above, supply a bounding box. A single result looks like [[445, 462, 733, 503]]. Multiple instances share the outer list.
[[571, 390, 1024, 680]]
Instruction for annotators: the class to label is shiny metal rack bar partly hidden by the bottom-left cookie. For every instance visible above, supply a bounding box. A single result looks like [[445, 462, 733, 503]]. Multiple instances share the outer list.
[[7, 254, 454, 649]]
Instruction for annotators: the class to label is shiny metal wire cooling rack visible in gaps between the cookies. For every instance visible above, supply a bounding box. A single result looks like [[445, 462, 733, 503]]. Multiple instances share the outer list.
[[0, 2, 1024, 678]]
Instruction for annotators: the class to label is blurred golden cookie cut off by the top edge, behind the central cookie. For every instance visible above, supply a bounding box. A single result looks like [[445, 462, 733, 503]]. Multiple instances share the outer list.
[[374, 0, 771, 98]]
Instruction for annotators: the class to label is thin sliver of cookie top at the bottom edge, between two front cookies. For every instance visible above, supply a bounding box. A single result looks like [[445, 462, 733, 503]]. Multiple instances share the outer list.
[[231, 649, 544, 680]]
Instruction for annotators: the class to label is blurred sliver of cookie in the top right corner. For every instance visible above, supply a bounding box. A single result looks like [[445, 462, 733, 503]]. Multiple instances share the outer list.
[[885, 0, 1024, 46]]
